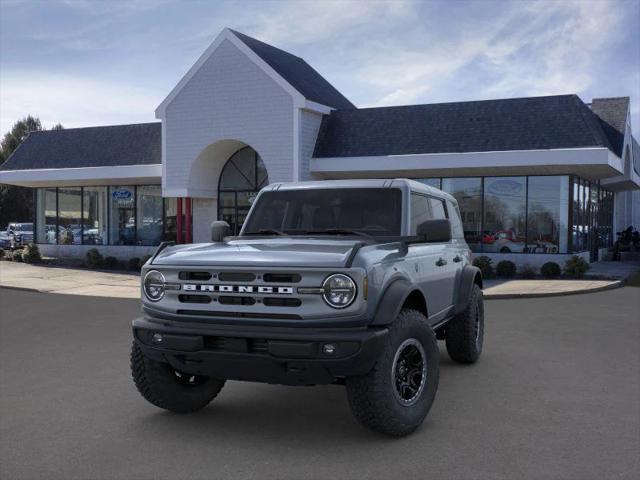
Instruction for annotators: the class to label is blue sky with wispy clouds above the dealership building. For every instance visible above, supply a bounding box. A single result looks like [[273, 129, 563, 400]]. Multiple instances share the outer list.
[[0, 0, 640, 136]]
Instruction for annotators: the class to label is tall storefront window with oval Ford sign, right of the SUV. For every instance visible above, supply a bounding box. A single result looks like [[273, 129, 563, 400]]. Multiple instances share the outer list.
[[482, 177, 527, 253]]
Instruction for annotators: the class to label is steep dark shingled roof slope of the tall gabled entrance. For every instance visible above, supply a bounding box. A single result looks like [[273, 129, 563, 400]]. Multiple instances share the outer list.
[[229, 29, 356, 109]]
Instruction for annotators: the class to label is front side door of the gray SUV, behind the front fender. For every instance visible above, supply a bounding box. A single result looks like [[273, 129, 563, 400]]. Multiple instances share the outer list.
[[407, 192, 451, 323]]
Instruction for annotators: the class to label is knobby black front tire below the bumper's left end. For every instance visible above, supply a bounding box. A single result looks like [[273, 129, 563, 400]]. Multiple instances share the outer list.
[[131, 342, 225, 413]]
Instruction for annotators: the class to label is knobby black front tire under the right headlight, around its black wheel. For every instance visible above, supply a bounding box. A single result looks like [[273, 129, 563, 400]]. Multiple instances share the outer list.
[[346, 309, 440, 436]]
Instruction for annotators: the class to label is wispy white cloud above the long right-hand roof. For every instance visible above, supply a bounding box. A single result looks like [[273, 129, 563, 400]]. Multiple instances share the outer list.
[[348, 1, 622, 106]]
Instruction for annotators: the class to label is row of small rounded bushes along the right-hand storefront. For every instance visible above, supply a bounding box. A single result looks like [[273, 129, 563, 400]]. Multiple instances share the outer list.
[[473, 255, 591, 278]]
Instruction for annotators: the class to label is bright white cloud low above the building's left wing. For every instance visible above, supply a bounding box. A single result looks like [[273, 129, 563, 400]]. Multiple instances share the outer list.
[[0, 71, 160, 132]]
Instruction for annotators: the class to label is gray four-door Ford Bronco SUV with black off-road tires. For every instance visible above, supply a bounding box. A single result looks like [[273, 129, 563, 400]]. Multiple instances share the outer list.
[[131, 179, 484, 435]]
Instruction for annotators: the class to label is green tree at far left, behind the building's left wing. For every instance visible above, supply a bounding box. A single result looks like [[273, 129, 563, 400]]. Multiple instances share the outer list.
[[0, 115, 63, 229]]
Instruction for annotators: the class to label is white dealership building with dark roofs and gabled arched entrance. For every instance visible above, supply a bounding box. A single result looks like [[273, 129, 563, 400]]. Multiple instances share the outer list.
[[0, 29, 640, 265]]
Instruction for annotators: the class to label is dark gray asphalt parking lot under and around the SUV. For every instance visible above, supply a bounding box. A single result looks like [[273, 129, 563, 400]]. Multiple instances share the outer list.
[[0, 287, 640, 480]]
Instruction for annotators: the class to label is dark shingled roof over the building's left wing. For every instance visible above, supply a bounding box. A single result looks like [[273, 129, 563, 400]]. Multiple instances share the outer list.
[[0, 122, 162, 170]]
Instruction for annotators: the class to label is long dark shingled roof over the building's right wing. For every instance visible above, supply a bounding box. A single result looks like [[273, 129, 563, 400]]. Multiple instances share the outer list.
[[314, 95, 612, 158]]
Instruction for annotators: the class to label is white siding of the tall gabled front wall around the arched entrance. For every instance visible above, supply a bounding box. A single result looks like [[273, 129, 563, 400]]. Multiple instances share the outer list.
[[163, 40, 294, 198]]
